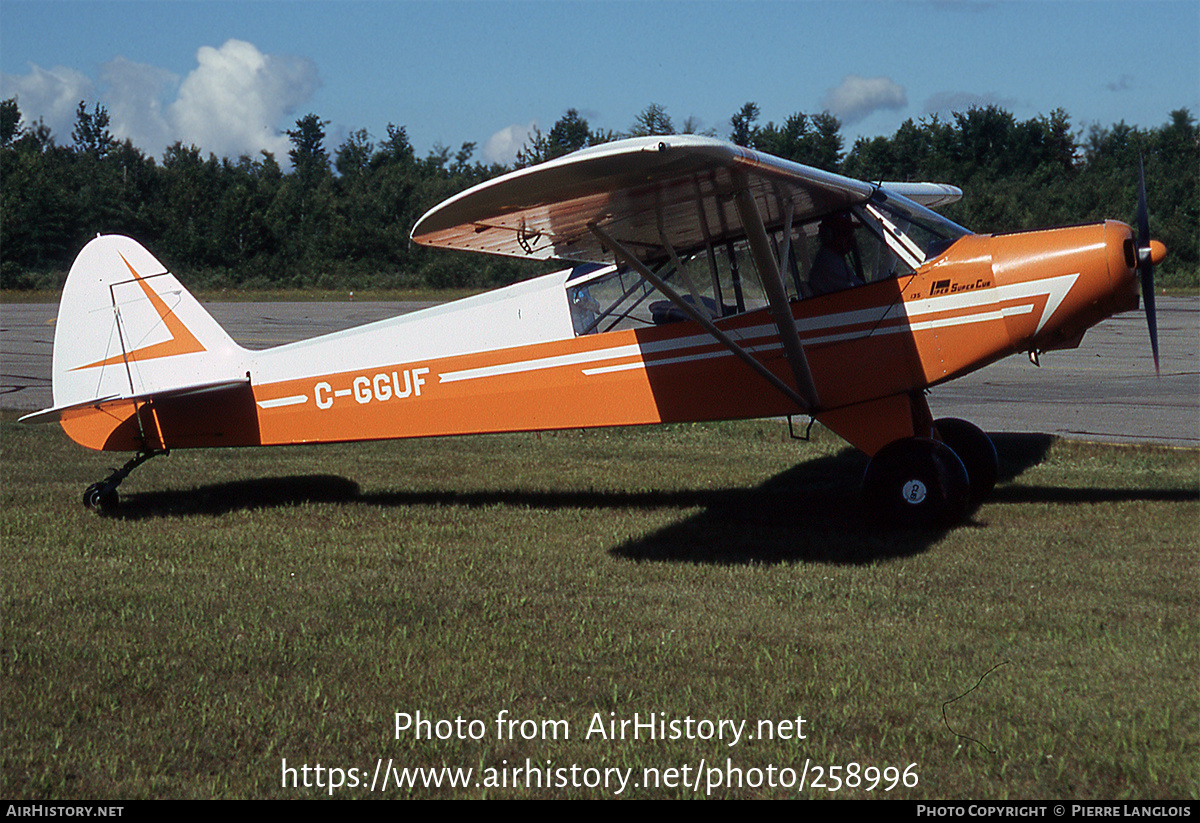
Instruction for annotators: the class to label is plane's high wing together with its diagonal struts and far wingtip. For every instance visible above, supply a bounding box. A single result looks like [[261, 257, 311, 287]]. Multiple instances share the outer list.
[[412, 134, 958, 412]]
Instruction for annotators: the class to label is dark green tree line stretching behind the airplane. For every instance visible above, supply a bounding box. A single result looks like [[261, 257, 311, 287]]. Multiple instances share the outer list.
[[0, 98, 1200, 289]]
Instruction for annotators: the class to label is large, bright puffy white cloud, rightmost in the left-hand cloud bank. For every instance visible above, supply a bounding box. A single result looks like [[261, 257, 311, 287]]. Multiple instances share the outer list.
[[169, 40, 320, 164]]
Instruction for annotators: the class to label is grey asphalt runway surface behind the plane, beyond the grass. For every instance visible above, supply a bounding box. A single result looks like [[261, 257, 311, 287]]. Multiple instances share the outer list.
[[0, 296, 1200, 447]]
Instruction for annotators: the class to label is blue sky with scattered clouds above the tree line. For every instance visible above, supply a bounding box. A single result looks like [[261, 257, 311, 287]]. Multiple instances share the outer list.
[[0, 0, 1200, 167]]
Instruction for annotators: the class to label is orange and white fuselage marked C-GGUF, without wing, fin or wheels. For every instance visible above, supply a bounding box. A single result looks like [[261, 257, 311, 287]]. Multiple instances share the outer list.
[[62, 222, 1138, 453]]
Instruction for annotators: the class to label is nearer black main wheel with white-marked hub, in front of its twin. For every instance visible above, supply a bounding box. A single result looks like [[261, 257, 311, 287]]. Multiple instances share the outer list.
[[863, 437, 971, 528]]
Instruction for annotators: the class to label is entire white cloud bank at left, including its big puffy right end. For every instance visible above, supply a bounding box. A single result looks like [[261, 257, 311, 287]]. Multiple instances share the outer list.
[[0, 40, 320, 167]]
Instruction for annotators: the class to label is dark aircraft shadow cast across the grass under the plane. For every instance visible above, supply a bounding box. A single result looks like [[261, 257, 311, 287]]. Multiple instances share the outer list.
[[108, 433, 1200, 565]]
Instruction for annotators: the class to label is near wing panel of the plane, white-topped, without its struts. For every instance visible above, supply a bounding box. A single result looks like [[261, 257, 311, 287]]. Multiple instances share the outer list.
[[412, 134, 876, 263]]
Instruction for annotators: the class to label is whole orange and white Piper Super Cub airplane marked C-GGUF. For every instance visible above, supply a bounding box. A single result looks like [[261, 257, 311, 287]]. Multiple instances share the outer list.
[[23, 134, 1166, 528]]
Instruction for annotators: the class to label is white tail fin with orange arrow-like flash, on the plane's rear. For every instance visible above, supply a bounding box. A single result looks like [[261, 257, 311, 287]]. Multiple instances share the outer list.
[[53, 235, 245, 407]]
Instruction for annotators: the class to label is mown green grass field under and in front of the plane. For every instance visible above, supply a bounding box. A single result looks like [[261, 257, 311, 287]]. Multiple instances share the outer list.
[[0, 415, 1200, 799]]
